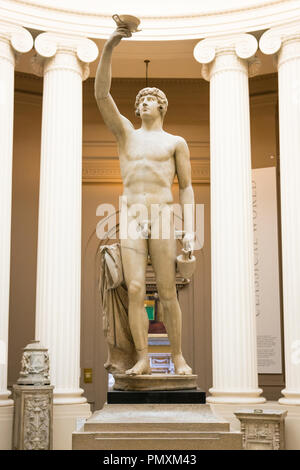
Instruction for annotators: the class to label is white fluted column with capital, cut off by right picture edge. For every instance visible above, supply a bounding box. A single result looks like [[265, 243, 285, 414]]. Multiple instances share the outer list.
[[260, 22, 300, 405]]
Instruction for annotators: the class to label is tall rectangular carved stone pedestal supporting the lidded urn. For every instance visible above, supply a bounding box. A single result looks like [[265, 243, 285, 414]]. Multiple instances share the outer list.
[[13, 385, 54, 450]]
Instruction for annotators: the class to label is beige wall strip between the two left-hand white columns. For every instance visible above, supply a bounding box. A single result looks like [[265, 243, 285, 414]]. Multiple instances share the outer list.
[[8, 91, 42, 386]]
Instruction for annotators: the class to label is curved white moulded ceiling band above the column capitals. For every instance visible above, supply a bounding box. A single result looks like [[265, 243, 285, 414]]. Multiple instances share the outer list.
[[0, 0, 300, 41]]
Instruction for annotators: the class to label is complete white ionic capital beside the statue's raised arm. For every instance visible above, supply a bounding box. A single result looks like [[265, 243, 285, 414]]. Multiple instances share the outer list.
[[32, 33, 98, 80]]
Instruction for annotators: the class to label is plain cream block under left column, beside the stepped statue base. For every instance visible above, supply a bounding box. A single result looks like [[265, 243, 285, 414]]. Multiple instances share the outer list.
[[53, 403, 92, 450]]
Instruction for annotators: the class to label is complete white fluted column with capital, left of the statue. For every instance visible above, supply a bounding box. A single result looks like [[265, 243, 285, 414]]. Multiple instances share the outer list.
[[35, 33, 98, 404]]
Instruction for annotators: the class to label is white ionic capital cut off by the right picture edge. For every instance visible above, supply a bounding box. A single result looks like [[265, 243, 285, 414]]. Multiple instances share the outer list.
[[259, 22, 300, 66]]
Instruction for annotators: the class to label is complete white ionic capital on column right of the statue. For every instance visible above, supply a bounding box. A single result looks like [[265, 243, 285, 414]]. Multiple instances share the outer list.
[[194, 34, 258, 80]]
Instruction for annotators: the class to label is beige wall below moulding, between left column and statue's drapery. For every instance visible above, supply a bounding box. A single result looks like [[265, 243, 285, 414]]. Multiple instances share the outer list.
[[81, 183, 122, 408]]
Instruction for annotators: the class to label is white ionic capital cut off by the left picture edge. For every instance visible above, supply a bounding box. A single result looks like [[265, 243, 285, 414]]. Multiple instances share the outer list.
[[0, 21, 33, 65]]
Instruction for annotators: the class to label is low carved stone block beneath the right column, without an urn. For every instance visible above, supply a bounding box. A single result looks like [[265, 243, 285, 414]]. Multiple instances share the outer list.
[[234, 409, 287, 450]]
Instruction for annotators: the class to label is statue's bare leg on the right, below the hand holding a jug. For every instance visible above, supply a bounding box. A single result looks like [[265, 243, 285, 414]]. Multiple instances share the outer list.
[[149, 208, 192, 375]]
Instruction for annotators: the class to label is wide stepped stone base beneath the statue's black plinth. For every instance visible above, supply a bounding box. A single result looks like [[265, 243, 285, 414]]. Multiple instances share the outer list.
[[73, 403, 242, 450]]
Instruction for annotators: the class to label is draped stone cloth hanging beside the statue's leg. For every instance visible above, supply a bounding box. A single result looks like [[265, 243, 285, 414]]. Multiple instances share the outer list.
[[99, 243, 137, 374]]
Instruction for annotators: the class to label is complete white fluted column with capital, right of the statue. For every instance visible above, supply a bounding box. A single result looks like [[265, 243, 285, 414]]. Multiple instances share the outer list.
[[194, 34, 265, 403]]
